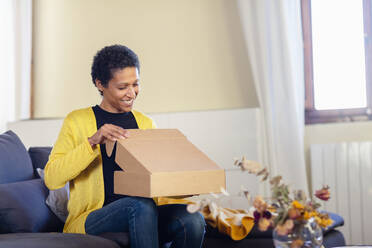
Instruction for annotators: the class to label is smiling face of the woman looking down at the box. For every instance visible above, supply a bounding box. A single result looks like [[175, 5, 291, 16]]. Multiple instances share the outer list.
[[96, 67, 140, 113]]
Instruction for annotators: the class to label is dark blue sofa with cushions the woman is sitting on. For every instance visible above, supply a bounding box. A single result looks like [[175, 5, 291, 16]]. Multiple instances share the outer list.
[[0, 131, 345, 248]]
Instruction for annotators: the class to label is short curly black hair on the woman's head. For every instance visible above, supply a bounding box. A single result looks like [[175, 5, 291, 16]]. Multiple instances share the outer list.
[[91, 45, 140, 95]]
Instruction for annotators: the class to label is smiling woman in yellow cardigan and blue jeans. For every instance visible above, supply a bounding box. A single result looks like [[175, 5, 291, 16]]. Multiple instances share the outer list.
[[45, 45, 205, 248]]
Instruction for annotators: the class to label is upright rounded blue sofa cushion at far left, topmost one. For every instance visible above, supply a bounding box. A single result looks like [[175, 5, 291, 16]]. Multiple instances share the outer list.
[[0, 131, 34, 184]]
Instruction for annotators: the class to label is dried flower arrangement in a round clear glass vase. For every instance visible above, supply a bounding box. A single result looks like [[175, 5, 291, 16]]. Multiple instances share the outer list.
[[187, 157, 332, 248]]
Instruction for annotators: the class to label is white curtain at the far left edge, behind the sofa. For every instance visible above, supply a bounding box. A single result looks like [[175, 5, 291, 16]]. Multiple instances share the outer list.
[[0, 0, 32, 133]]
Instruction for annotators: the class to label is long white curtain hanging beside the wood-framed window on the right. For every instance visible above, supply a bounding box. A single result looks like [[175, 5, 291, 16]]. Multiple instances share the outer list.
[[238, 0, 308, 193]]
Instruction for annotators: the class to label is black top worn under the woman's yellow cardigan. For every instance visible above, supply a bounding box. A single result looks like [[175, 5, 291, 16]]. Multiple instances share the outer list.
[[92, 105, 138, 205]]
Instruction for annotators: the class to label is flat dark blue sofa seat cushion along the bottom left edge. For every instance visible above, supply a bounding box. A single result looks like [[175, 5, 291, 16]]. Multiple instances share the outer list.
[[0, 233, 119, 248]]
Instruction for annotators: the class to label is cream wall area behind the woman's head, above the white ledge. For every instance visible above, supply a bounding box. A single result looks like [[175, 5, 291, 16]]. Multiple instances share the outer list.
[[33, 0, 258, 118]]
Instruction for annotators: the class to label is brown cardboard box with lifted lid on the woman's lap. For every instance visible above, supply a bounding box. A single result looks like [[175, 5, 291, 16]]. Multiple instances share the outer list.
[[106, 129, 226, 197]]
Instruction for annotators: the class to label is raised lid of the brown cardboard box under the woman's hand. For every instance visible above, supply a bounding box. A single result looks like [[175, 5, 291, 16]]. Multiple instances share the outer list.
[[106, 129, 221, 174]]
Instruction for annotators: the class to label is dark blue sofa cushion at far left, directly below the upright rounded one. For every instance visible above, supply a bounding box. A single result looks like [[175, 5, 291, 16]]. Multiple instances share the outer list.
[[0, 179, 63, 233]]
